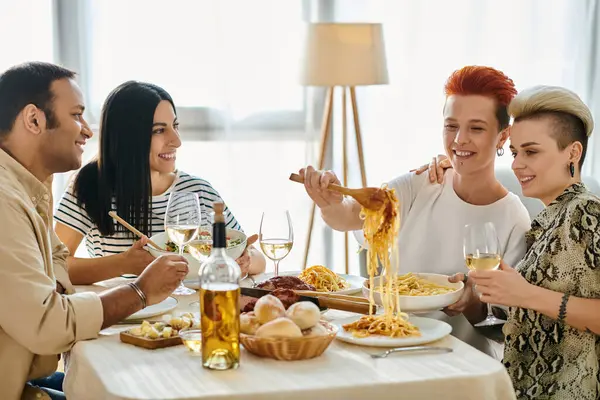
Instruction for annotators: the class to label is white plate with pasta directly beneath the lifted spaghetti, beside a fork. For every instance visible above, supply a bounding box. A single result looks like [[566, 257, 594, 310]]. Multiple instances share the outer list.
[[335, 315, 452, 347]]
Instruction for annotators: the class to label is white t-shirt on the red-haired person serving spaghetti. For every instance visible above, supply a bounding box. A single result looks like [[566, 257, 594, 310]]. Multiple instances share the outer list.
[[355, 169, 531, 356]]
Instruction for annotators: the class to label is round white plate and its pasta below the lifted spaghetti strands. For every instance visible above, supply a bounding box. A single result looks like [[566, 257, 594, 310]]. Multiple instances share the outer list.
[[335, 314, 452, 347]]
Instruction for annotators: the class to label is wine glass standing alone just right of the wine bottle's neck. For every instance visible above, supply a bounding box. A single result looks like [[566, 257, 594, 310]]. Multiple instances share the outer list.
[[258, 210, 294, 276]]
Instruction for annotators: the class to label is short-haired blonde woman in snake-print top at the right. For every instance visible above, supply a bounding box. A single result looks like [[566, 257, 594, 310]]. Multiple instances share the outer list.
[[420, 86, 600, 400]]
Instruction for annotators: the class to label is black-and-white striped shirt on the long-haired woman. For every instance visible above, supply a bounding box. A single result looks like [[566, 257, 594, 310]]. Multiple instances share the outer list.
[[55, 171, 241, 257]]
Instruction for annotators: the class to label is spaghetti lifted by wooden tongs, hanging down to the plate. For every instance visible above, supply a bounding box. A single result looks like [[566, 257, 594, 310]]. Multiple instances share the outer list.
[[344, 185, 421, 337]]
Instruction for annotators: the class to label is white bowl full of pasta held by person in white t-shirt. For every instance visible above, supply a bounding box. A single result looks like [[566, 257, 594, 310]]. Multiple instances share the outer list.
[[362, 273, 465, 313]]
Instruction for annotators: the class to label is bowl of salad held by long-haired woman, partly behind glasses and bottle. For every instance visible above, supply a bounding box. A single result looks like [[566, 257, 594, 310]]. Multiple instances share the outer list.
[[148, 228, 248, 282]]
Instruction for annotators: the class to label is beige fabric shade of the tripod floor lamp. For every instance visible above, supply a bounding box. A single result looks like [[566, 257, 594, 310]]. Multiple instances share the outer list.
[[300, 23, 388, 86]]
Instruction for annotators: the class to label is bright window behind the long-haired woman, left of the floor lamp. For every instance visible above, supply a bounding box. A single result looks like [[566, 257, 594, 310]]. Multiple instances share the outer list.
[[89, 0, 304, 127]]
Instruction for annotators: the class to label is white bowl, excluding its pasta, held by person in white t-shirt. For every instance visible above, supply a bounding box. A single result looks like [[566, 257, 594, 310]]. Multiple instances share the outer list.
[[362, 273, 465, 313]]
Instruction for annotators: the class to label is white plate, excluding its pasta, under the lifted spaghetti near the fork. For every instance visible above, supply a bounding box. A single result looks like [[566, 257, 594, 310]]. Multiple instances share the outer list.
[[333, 316, 452, 347]]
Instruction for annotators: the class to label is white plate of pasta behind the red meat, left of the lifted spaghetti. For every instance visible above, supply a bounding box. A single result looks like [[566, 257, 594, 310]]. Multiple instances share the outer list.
[[254, 265, 365, 294]]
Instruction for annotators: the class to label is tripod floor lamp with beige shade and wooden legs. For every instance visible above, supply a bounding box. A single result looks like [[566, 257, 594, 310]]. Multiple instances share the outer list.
[[301, 23, 388, 273]]
